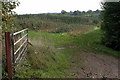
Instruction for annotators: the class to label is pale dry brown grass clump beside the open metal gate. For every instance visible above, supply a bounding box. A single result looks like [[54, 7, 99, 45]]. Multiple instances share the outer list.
[[28, 37, 54, 69]]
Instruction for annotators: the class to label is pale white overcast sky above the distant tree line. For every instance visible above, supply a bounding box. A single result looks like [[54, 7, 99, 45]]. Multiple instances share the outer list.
[[14, 0, 101, 14]]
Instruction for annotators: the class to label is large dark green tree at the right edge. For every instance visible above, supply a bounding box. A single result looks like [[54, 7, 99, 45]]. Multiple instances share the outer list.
[[101, 2, 120, 50]]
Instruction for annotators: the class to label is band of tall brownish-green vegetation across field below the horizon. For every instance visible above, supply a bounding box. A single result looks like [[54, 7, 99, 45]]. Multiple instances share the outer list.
[[15, 14, 99, 32]]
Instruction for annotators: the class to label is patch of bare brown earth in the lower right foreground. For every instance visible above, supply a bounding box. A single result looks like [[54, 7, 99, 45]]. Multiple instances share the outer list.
[[70, 52, 118, 78]]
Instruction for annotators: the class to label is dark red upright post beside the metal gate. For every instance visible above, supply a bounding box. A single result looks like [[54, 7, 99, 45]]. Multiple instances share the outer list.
[[5, 32, 12, 79]]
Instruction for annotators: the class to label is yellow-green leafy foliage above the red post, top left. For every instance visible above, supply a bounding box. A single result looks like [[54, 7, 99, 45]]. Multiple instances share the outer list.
[[2, 0, 19, 32]]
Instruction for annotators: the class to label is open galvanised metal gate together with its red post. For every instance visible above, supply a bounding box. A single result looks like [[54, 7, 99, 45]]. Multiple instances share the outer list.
[[5, 29, 28, 78]]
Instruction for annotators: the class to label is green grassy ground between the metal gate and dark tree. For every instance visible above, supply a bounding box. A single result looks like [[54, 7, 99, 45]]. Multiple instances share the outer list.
[[15, 28, 120, 78]]
